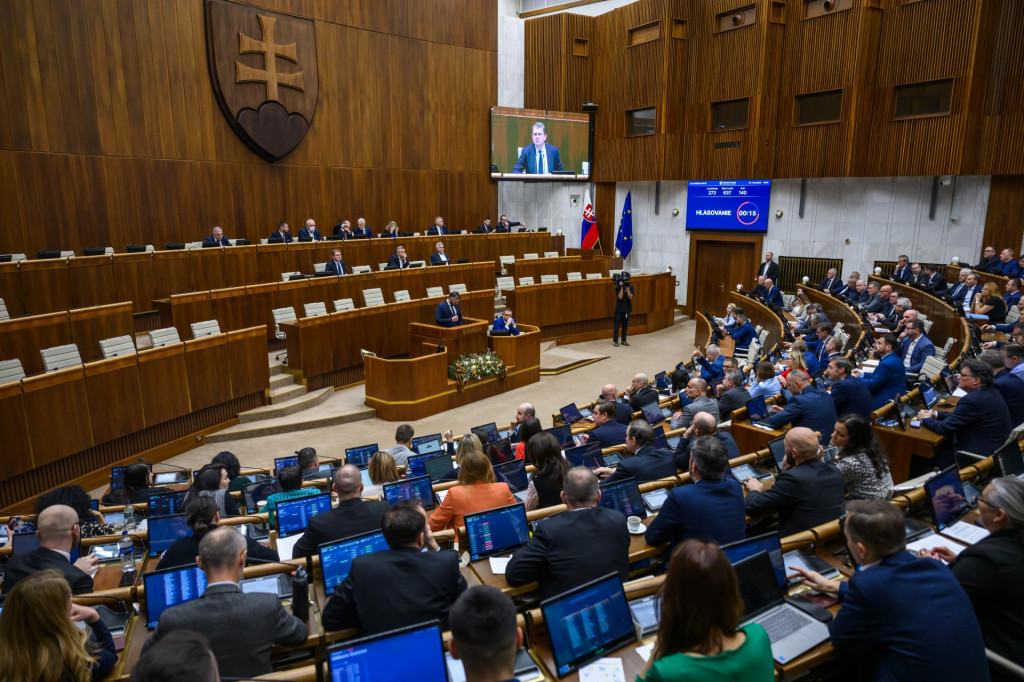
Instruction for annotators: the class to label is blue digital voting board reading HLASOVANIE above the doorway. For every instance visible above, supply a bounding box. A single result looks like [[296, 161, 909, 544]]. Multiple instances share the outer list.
[[686, 180, 771, 232]]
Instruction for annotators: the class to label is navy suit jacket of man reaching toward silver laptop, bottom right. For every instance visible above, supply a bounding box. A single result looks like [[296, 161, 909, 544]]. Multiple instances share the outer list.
[[828, 552, 991, 682]]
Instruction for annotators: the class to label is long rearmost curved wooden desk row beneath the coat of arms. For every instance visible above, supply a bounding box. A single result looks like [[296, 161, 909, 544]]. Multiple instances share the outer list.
[[0, 232, 565, 316]]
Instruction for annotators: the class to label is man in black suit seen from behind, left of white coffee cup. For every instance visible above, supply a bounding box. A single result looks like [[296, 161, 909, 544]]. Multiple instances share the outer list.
[[505, 467, 630, 599]]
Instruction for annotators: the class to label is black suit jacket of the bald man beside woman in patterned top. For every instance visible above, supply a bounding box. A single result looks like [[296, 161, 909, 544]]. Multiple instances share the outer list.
[[743, 456, 845, 538]]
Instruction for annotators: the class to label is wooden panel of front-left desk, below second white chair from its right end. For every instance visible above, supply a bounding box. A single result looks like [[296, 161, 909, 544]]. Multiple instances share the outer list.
[[138, 343, 191, 426]]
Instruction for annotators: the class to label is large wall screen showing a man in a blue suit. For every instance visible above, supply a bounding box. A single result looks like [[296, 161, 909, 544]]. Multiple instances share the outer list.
[[490, 106, 590, 181]]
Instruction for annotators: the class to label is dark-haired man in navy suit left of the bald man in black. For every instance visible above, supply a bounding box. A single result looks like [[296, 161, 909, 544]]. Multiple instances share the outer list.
[[644, 436, 746, 556]]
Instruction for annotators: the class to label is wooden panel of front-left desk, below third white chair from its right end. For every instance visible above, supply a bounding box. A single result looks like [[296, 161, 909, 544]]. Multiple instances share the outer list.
[[84, 355, 145, 444]]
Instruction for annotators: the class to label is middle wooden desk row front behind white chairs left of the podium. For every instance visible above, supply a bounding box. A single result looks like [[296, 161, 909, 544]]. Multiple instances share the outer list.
[[154, 263, 495, 339]]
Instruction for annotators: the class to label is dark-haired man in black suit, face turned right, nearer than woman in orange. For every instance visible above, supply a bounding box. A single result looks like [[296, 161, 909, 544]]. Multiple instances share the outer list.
[[322, 493, 466, 635]]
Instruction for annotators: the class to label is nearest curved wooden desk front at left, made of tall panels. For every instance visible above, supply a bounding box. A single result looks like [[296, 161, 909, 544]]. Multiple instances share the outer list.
[[0, 327, 270, 508]]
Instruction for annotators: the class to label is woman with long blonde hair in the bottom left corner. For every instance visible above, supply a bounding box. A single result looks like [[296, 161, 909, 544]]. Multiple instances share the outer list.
[[0, 569, 118, 682]]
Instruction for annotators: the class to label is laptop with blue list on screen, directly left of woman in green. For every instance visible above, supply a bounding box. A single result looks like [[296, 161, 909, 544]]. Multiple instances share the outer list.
[[541, 573, 637, 677]]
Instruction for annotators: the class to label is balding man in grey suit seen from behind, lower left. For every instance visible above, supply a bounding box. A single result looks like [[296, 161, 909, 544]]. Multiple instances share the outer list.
[[142, 526, 308, 679]]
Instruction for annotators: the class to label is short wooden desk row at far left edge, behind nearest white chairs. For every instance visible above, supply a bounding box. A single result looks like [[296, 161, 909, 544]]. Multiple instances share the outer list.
[[0, 302, 135, 375]]
